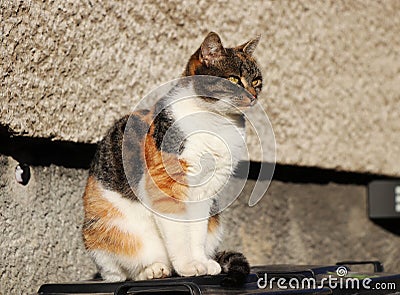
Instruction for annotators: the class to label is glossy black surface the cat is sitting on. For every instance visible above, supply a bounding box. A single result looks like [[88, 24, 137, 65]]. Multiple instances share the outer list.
[[38, 261, 400, 295]]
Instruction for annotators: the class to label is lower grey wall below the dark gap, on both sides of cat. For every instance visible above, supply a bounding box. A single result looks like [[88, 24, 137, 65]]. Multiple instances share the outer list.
[[0, 156, 400, 294]]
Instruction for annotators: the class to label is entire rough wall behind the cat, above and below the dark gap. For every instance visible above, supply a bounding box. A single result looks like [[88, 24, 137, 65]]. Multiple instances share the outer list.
[[0, 0, 400, 294]]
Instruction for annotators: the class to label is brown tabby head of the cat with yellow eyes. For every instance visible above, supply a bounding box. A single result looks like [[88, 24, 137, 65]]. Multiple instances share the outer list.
[[184, 32, 262, 112]]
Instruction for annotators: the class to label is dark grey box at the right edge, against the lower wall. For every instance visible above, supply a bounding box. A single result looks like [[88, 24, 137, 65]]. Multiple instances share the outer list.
[[368, 179, 400, 235]]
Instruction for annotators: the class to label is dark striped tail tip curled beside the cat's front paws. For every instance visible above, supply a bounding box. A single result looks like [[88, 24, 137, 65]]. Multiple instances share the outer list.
[[215, 251, 250, 287]]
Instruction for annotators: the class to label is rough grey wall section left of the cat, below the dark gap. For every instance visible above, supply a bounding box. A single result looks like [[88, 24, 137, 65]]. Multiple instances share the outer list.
[[0, 155, 95, 295]]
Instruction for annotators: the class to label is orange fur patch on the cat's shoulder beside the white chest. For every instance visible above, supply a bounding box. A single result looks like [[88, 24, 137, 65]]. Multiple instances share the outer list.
[[144, 126, 187, 213]]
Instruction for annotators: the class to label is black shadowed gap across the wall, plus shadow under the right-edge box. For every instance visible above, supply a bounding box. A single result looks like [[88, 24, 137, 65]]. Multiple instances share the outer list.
[[0, 125, 400, 235]]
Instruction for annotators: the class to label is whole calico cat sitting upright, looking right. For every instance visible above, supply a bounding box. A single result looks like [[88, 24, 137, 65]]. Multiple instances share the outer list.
[[83, 32, 262, 285]]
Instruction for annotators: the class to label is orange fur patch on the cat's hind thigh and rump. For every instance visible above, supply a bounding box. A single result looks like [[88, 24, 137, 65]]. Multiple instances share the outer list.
[[83, 176, 142, 256]]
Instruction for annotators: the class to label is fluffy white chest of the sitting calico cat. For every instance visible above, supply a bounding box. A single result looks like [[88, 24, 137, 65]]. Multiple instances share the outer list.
[[173, 104, 246, 200]]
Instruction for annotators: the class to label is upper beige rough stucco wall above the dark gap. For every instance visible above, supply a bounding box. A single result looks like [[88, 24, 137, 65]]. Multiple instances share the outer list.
[[0, 0, 400, 176]]
